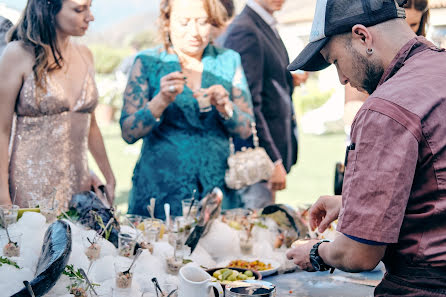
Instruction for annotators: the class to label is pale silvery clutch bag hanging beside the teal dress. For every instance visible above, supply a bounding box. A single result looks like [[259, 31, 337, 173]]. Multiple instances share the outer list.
[[225, 123, 274, 190]]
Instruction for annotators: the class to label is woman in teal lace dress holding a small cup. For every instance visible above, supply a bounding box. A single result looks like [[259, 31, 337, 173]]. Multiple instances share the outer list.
[[120, 0, 254, 218]]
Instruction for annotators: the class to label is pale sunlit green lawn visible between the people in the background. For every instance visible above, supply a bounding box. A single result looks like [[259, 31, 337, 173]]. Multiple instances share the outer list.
[[90, 123, 345, 211]]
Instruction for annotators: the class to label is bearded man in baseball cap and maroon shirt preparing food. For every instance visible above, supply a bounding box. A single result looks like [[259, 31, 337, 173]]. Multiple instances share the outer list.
[[287, 0, 446, 296]]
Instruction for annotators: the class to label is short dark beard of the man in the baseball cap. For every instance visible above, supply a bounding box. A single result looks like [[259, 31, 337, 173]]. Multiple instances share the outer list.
[[351, 49, 384, 94]]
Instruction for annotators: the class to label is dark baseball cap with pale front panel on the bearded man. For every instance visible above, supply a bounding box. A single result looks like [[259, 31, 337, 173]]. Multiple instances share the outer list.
[[288, 0, 407, 71]]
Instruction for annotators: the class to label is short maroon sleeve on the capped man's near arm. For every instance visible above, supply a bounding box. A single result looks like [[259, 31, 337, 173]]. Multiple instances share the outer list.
[[338, 109, 418, 243]]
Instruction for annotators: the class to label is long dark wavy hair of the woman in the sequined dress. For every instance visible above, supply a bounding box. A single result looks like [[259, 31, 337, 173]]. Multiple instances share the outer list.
[[7, 0, 64, 87]]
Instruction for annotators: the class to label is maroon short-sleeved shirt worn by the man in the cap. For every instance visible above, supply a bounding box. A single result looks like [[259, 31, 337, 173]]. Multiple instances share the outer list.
[[338, 37, 446, 270]]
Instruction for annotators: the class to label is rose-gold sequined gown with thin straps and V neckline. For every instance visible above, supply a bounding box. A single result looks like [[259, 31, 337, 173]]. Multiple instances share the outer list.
[[9, 70, 98, 208]]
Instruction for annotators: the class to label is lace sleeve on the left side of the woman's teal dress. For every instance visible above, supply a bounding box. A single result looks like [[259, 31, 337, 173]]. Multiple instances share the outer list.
[[119, 57, 158, 143]]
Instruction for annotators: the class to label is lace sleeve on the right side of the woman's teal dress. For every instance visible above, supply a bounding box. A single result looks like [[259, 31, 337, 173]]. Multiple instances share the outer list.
[[224, 58, 254, 139]]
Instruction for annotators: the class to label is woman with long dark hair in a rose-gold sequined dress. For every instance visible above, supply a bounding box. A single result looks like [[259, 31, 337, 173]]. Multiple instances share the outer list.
[[0, 0, 115, 208]]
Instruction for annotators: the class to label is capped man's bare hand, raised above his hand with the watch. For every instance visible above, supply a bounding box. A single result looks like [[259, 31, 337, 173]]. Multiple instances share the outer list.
[[310, 196, 342, 233]]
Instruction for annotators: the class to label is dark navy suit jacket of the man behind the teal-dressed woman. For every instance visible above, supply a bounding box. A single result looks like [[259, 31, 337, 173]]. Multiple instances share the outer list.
[[223, 6, 297, 172]]
